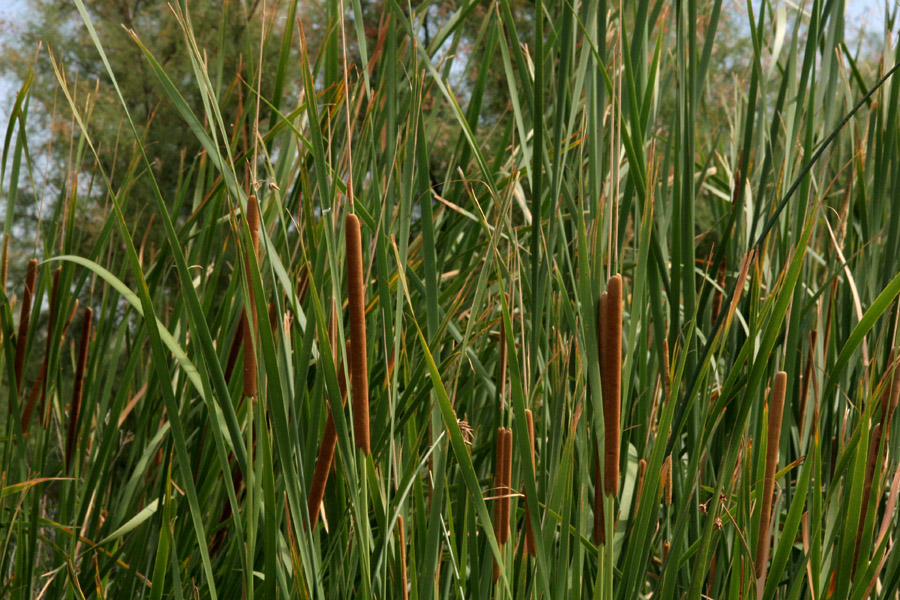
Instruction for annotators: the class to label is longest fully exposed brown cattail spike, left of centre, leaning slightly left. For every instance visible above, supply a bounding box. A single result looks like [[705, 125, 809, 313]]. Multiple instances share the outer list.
[[345, 214, 371, 454]]
